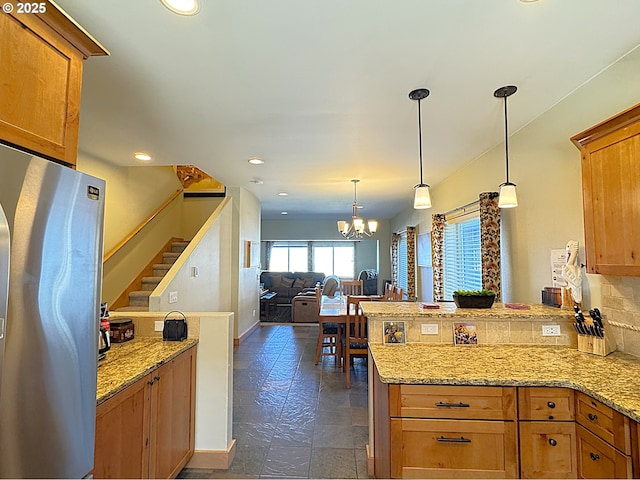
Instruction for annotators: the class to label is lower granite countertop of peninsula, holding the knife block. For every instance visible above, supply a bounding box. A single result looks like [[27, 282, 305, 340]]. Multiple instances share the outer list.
[[369, 343, 640, 422]]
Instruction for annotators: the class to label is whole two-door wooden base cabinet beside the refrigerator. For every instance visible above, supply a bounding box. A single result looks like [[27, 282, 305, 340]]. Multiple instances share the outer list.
[[94, 347, 196, 478]]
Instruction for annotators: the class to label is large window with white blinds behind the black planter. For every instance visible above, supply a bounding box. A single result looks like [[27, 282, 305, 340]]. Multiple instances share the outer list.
[[443, 217, 482, 300]]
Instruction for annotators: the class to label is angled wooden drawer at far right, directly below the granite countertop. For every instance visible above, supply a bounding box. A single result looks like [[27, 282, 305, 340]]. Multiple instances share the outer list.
[[576, 392, 631, 455]]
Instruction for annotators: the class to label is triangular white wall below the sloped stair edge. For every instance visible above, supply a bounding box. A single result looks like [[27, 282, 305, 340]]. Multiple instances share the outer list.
[[149, 199, 235, 312]]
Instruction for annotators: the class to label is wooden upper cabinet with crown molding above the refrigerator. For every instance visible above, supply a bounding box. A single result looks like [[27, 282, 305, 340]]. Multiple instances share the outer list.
[[0, 1, 109, 165]]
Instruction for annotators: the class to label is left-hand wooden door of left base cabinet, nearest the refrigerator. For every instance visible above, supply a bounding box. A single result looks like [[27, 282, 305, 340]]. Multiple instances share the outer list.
[[93, 376, 151, 478]]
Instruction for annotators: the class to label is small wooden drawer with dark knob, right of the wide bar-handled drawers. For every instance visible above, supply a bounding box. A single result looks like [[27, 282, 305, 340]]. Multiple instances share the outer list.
[[518, 387, 575, 421]]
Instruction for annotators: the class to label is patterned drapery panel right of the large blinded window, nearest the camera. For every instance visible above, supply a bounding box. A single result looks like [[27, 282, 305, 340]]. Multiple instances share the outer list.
[[480, 192, 501, 301]]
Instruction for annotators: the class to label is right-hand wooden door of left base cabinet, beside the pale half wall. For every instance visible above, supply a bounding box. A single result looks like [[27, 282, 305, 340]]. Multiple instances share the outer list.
[[149, 347, 196, 478]]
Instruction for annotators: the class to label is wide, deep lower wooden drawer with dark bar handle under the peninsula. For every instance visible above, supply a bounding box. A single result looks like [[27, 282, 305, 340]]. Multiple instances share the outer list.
[[391, 418, 518, 478]]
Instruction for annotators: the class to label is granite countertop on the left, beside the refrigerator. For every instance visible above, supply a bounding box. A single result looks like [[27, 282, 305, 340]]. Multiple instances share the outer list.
[[96, 337, 198, 405]]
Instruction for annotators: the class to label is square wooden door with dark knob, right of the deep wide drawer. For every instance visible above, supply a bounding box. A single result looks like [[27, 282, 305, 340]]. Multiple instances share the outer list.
[[519, 422, 578, 478]]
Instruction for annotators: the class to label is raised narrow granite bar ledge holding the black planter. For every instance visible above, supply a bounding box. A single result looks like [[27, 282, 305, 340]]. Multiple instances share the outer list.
[[361, 302, 573, 319]]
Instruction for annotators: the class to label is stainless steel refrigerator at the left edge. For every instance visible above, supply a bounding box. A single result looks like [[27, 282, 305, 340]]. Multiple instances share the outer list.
[[0, 146, 105, 478]]
